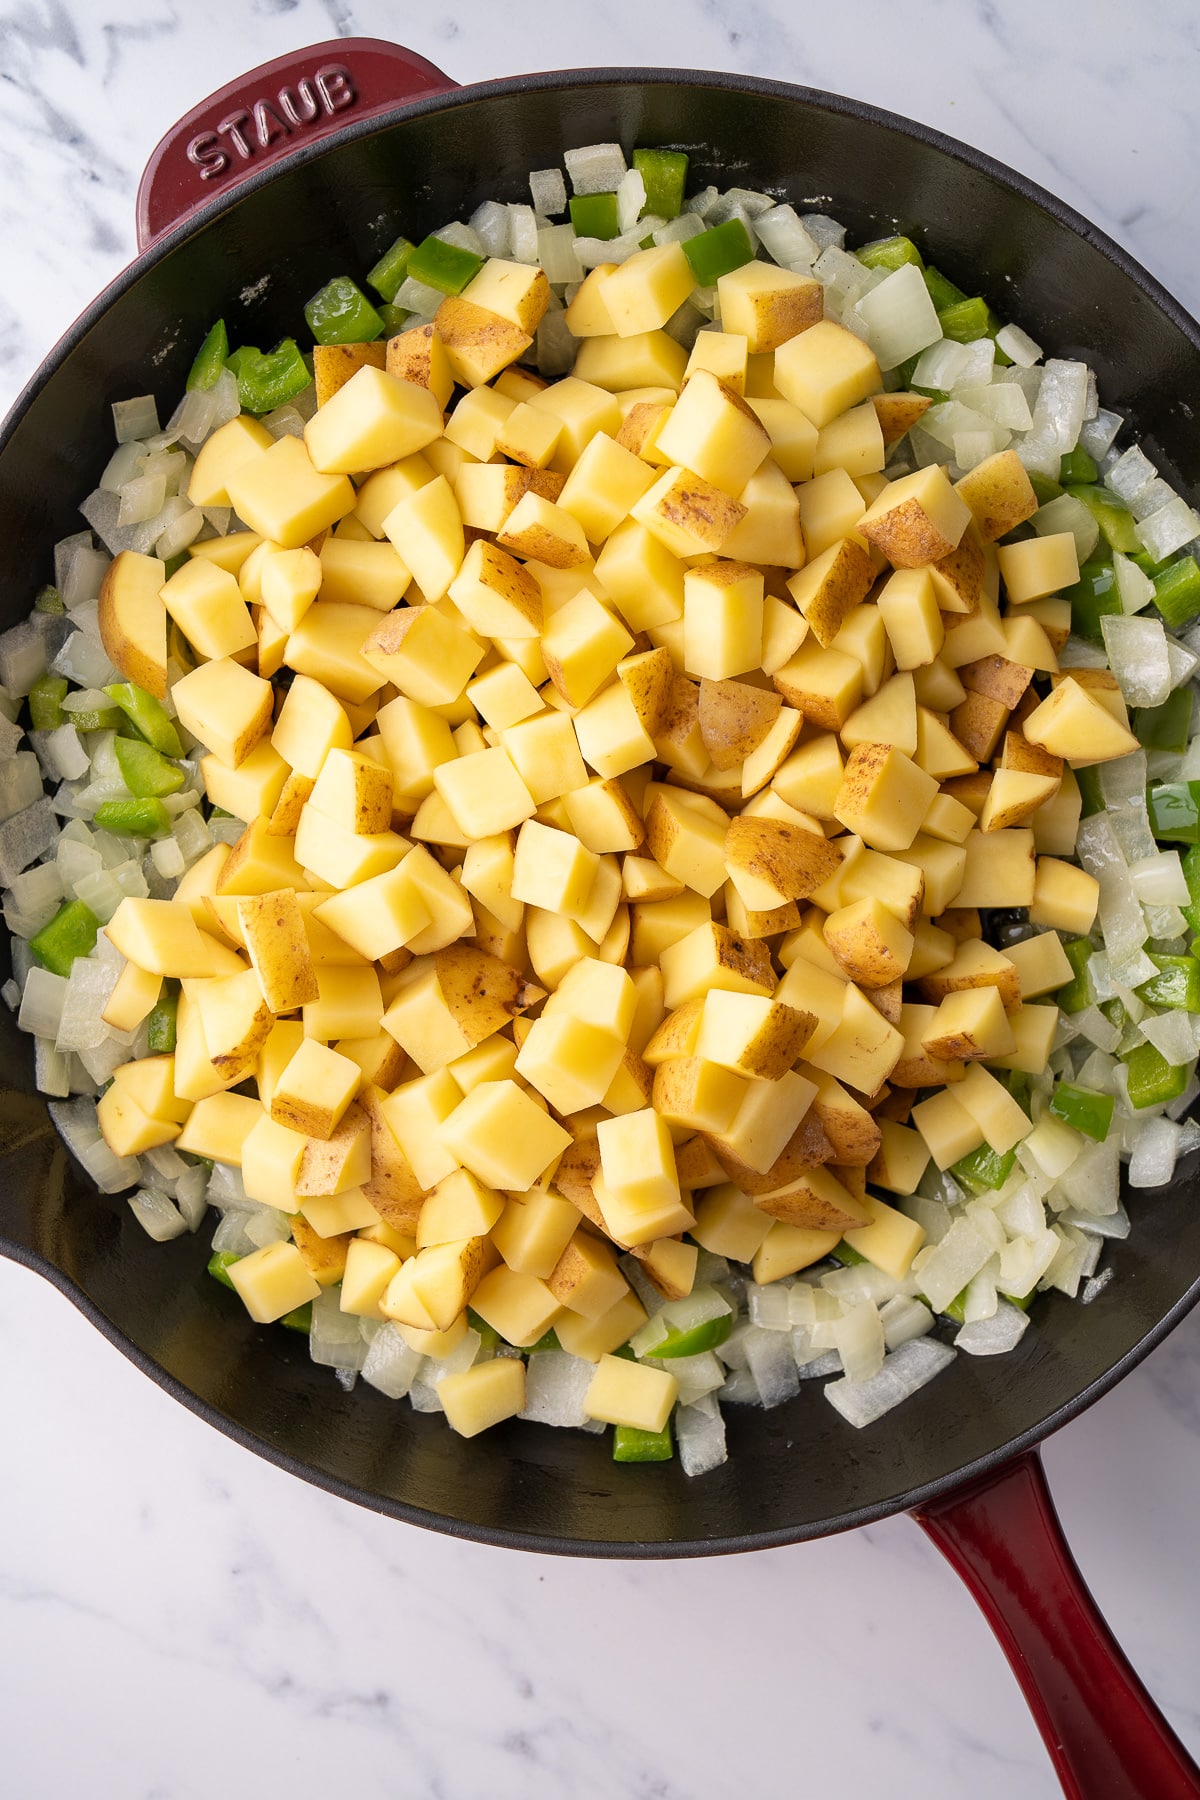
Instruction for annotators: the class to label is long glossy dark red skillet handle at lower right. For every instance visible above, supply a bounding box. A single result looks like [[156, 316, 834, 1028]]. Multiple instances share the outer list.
[[916, 1451, 1200, 1800]]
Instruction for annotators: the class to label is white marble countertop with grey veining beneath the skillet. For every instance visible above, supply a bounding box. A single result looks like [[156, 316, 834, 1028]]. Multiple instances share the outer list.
[[0, 0, 1200, 1800]]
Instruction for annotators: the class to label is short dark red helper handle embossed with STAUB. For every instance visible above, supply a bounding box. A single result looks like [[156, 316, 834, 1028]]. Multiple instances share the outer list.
[[137, 38, 457, 250]]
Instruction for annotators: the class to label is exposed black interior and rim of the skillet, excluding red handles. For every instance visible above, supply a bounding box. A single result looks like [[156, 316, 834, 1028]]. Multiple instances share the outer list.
[[0, 72, 1200, 1555]]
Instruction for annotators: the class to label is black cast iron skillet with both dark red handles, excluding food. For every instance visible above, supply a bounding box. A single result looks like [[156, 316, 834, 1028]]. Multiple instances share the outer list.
[[0, 40, 1200, 1800]]
